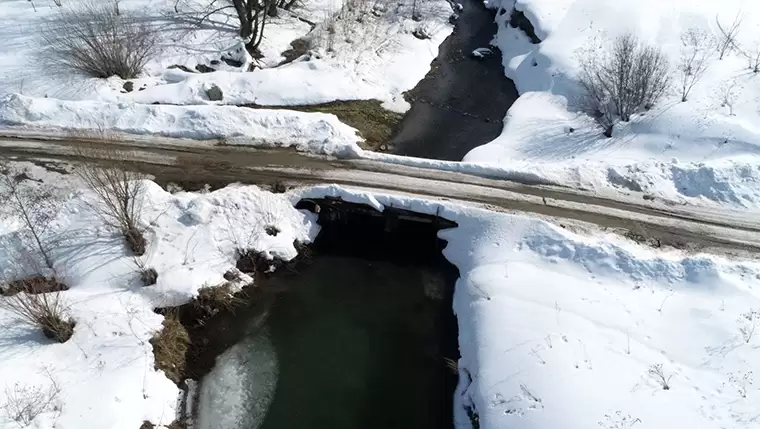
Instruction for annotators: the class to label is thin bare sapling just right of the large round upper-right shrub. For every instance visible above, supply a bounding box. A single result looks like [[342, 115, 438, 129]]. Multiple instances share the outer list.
[[678, 28, 715, 102]]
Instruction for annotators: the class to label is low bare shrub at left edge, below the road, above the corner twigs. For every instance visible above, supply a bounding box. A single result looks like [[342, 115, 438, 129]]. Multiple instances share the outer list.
[[0, 292, 75, 343]]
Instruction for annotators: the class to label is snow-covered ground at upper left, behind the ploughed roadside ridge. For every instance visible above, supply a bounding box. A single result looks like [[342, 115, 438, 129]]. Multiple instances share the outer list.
[[0, 0, 452, 108]]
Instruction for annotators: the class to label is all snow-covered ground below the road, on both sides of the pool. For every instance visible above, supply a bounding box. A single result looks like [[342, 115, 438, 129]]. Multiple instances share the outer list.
[[0, 162, 760, 429]]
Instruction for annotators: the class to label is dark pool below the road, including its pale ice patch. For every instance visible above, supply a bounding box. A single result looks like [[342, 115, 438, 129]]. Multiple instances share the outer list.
[[196, 201, 459, 429]]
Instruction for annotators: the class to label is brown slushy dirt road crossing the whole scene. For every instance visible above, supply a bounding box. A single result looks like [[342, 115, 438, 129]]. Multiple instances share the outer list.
[[0, 137, 760, 255]]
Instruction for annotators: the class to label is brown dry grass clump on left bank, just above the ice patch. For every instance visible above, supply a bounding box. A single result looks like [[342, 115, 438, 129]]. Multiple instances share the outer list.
[[150, 310, 190, 383]]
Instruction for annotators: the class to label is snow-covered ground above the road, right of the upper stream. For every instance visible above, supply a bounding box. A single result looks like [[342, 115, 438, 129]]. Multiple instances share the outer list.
[[464, 0, 760, 210]]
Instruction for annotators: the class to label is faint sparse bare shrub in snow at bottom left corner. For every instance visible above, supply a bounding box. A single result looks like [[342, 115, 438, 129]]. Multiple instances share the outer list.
[[3, 377, 61, 427]]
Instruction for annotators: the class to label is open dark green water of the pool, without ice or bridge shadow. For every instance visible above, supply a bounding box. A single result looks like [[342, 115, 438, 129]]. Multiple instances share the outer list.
[[262, 256, 451, 429]]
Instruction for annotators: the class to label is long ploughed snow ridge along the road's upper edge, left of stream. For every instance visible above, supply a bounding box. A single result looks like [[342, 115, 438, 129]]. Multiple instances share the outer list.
[[0, 94, 360, 155]]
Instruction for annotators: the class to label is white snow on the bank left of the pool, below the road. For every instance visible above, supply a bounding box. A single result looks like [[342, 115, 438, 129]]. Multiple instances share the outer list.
[[0, 171, 318, 429]]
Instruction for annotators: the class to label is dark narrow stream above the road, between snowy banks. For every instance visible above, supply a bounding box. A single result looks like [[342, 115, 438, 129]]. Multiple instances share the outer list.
[[391, 0, 518, 161]]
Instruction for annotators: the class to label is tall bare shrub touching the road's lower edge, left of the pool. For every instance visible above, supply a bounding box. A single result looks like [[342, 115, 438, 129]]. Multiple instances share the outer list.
[[76, 148, 147, 256]]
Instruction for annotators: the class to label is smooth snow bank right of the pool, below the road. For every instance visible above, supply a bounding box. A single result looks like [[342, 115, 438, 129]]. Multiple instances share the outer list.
[[303, 186, 760, 429]]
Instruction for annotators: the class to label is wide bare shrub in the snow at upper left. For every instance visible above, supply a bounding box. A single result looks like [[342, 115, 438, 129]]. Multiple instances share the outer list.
[[40, 0, 159, 79]]
